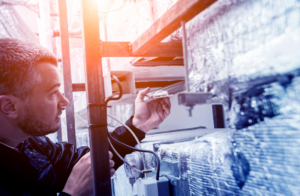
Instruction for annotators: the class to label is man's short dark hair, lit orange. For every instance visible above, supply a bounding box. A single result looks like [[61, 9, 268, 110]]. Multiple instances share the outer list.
[[0, 38, 57, 99]]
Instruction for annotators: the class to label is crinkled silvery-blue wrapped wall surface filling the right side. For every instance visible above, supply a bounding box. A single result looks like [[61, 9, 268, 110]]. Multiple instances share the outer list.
[[114, 0, 300, 195]]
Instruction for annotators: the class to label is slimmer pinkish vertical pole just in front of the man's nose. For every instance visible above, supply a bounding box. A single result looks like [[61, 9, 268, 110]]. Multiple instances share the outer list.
[[58, 0, 76, 146]]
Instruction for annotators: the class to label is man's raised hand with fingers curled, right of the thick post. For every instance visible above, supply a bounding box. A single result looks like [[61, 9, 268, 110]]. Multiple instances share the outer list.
[[132, 87, 171, 133]]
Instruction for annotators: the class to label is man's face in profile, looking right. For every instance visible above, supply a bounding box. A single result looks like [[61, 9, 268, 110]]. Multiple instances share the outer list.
[[18, 62, 69, 136]]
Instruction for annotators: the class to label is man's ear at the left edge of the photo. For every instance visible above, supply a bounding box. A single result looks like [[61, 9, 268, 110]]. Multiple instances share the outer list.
[[0, 95, 18, 119]]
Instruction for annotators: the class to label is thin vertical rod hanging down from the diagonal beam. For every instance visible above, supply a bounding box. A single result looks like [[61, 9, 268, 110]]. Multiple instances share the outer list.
[[181, 20, 190, 92]]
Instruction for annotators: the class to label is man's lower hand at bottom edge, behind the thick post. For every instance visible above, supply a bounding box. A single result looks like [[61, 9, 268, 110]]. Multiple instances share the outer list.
[[63, 152, 115, 196]]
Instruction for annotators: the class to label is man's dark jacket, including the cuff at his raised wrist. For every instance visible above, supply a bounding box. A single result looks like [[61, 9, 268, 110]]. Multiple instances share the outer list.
[[0, 117, 145, 196]]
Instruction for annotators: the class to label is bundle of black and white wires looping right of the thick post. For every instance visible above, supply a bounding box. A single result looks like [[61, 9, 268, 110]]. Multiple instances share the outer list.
[[105, 75, 160, 180]]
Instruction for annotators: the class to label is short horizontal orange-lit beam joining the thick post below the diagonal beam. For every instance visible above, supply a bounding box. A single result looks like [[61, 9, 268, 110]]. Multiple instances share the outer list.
[[100, 42, 183, 57]]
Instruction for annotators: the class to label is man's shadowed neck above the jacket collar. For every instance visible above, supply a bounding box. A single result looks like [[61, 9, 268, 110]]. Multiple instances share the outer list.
[[0, 119, 30, 147]]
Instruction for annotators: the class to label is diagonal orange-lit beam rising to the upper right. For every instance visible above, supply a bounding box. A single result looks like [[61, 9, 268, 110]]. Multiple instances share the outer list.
[[132, 0, 216, 55]]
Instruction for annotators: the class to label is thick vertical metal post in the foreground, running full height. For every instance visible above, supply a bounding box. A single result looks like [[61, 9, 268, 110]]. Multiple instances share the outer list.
[[82, 0, 111, 196]]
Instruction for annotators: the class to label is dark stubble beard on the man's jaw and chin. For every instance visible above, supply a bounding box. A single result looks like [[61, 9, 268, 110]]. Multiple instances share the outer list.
[[18, 107, 58, 136]]
